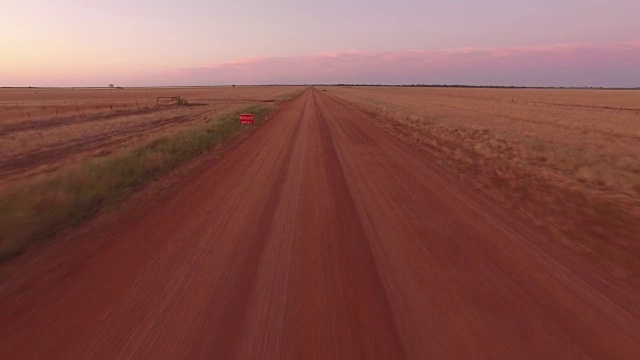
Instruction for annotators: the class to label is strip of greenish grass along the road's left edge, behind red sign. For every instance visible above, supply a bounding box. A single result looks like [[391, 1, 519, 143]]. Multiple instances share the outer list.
[[0, 105, 268, 261]]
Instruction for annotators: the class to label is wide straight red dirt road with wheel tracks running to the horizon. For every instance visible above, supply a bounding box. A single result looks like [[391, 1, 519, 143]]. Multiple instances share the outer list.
[[0, 89, 640, 359]]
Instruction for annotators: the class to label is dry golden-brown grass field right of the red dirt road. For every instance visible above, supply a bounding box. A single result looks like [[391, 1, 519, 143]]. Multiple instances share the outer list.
[[323, 87, 640, 280]]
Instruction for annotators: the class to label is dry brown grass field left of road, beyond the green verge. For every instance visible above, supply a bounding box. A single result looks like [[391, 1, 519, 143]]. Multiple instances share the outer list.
[[0, 86, 299, 184]]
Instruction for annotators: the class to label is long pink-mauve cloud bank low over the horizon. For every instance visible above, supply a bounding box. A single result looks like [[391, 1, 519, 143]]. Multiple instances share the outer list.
[[148, 41, 640, 87]]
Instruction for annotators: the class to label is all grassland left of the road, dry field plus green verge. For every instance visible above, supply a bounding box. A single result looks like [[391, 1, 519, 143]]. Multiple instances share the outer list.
[[0, 87, 301, 259]]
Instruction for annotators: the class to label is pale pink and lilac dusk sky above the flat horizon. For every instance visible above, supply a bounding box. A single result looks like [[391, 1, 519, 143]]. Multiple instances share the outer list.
[[0, 0, 640, 87]]
